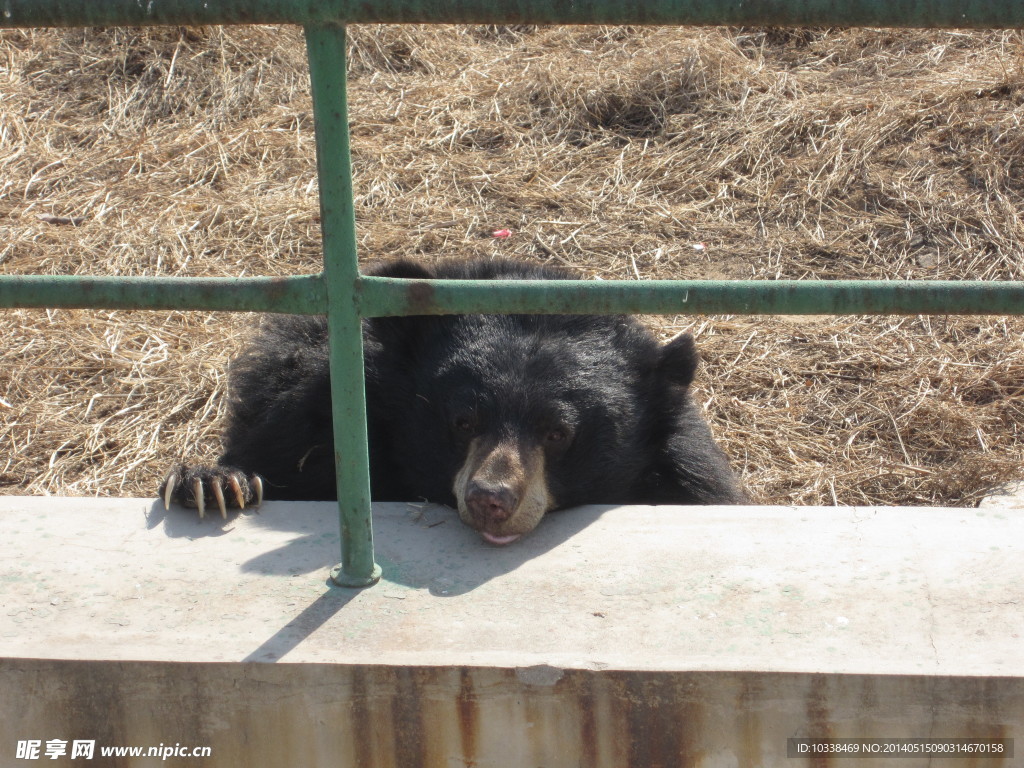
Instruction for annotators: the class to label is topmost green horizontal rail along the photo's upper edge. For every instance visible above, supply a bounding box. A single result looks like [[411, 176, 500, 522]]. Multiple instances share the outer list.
[[6, 0, 1024, 29]]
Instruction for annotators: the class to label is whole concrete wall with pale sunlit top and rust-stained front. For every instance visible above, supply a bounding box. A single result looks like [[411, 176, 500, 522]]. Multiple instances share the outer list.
[[0, 498, 1024, 768]]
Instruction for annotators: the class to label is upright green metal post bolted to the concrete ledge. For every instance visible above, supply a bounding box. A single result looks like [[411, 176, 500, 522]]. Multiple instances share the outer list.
[[305, 24, 381, 587]]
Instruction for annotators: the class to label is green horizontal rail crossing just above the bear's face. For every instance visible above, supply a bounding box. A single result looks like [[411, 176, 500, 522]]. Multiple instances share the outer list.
[[0, 274, 1024, 317]]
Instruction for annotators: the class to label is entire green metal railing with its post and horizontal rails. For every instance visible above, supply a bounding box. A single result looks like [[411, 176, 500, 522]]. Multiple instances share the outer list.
[[0, 0, 1024, 587]]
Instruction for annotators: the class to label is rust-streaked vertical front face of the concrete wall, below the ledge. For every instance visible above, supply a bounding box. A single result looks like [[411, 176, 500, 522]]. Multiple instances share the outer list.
[[0, 659, 1024, 768]]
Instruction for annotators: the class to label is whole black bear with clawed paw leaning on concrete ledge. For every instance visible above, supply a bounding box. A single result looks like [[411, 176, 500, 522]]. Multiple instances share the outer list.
[[160, 260, 748, 545]]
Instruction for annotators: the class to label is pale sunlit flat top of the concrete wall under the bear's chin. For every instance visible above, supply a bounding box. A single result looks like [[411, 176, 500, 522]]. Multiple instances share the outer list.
[[0, 498, 1024, 676]]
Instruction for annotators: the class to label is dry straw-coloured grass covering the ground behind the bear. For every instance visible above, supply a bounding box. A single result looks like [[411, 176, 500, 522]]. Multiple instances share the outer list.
[[0, 27, 1024, 506]]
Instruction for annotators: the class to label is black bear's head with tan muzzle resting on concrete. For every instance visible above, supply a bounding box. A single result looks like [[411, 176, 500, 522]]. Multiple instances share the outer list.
[[368, 301, 697, 545]]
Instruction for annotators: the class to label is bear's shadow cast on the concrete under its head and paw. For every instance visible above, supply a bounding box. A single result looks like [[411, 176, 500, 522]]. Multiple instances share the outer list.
[[146, 501, 610, 607]]
